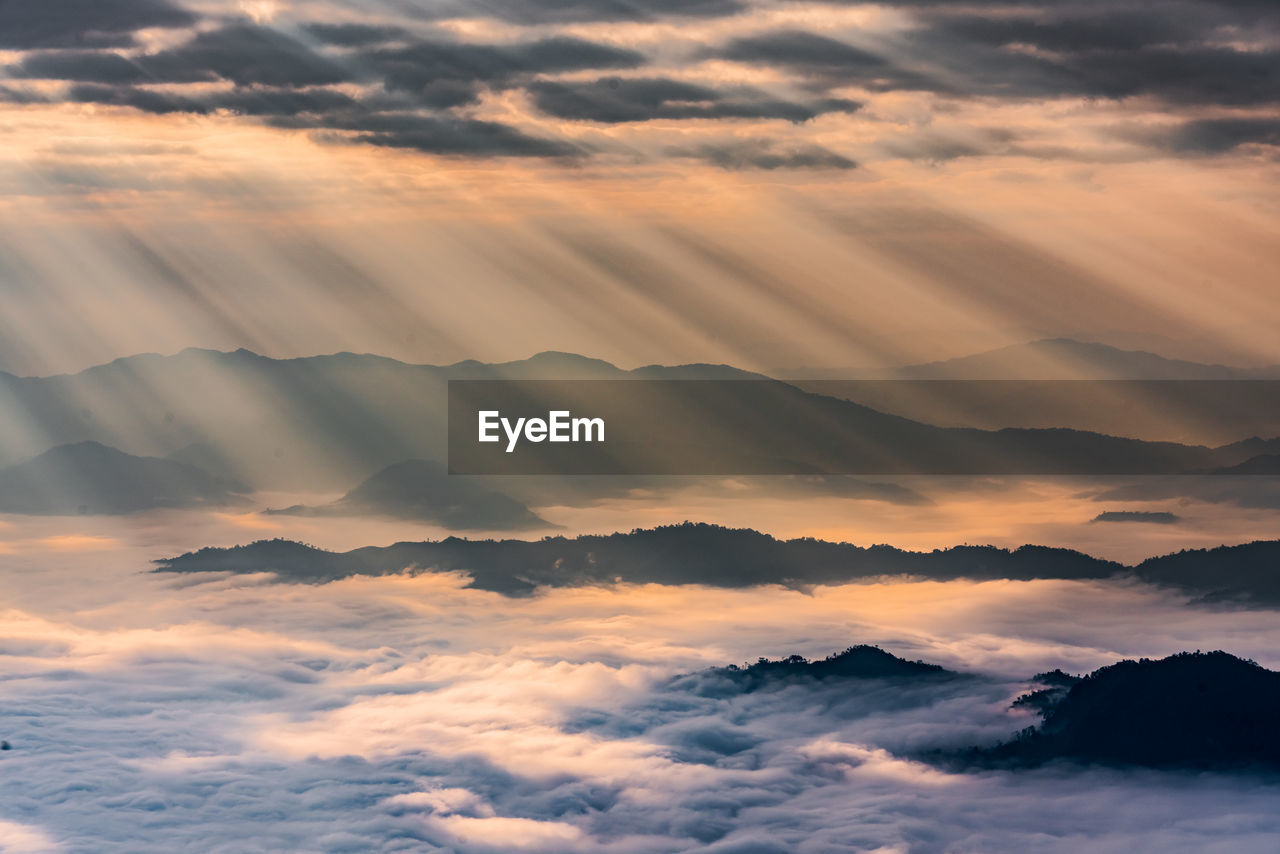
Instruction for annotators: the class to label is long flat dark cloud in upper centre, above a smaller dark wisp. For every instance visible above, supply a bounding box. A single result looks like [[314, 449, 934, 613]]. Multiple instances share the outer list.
[[529, 77, 860, 123]]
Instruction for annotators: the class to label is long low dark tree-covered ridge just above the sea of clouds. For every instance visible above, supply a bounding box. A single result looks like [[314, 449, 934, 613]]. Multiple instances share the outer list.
[[156, 522, 1280, 606]]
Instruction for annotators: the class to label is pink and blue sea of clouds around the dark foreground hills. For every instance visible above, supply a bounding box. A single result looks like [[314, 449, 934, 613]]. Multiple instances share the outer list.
[[0, 535, 1280, 854]]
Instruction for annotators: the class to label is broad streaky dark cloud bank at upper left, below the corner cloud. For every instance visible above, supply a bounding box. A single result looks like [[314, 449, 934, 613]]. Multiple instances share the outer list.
[[0, 23, 637, 157]]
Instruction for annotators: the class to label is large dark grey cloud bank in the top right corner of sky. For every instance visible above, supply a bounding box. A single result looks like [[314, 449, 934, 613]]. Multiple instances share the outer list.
[[714, 4, 1280, 105]]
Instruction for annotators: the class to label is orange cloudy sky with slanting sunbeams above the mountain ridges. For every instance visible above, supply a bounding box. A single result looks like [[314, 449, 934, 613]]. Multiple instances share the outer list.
[[0, 0, 1280, 374]]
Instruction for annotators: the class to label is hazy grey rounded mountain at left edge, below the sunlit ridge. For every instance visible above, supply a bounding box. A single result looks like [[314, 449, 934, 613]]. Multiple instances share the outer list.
[[0, 442, 242, 516]]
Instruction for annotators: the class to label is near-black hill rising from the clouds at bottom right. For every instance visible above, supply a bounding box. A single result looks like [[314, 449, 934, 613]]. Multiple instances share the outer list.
[[968, 652, 1280, 771]]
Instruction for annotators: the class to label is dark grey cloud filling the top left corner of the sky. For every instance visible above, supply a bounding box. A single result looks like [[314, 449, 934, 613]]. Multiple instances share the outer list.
[[0, 0, 196, 50]]
